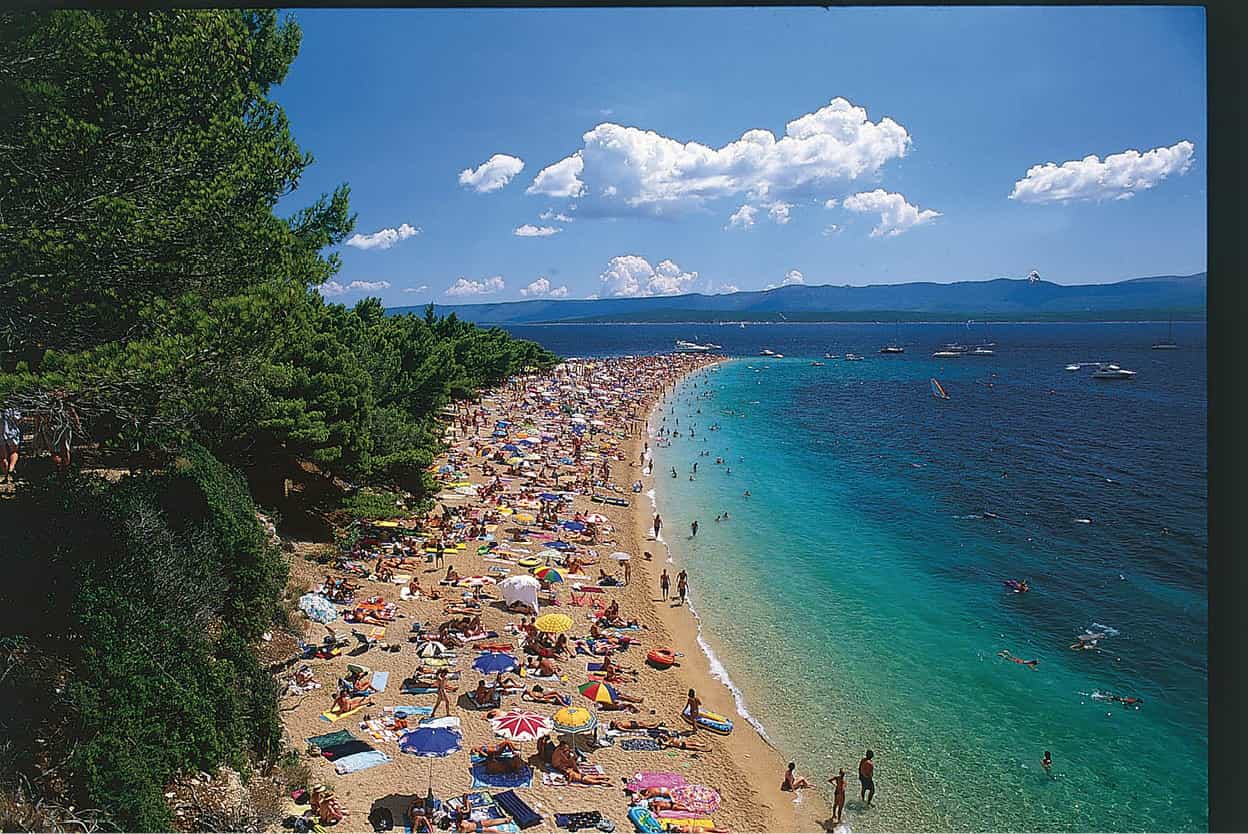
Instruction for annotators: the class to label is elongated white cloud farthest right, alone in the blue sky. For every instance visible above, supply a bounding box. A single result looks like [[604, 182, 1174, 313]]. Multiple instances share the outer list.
[[1010, 140, 1196, 202]]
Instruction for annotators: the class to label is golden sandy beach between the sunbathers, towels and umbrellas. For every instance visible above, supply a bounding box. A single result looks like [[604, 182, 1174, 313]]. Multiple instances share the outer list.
[[281, 355, 830, 832]]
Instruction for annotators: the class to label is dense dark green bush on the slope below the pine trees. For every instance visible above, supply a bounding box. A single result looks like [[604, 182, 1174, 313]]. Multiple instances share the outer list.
[[0, 447, 286, 830]]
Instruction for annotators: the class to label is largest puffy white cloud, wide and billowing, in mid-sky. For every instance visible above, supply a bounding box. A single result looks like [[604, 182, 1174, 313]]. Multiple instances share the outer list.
[[528, 99, 910, 216]]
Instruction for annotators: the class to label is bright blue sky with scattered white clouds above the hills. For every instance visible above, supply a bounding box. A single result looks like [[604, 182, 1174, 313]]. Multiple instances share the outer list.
[[273, 6, 1207, 306]]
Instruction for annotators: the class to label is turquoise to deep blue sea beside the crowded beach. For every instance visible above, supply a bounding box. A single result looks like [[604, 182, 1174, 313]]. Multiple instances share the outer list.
[[508, 322, 1208, 832]]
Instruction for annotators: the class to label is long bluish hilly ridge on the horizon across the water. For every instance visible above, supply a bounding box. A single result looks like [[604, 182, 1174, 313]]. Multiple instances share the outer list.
[[389, 272, 1206, 325]]
